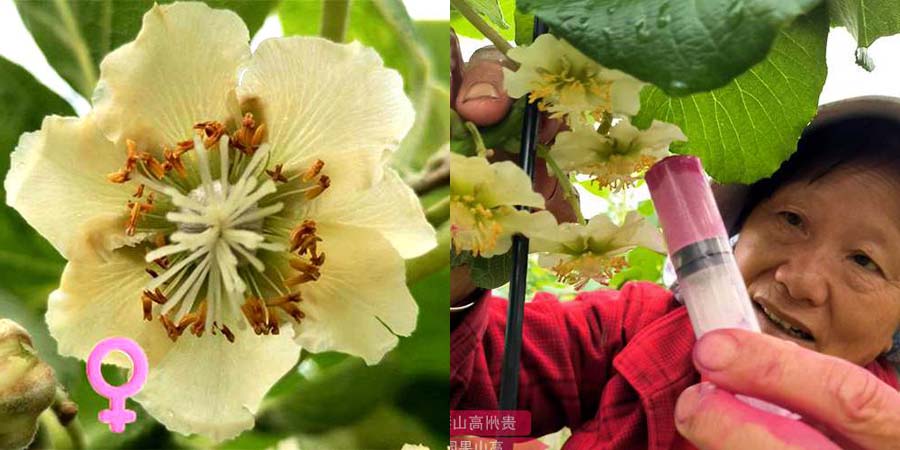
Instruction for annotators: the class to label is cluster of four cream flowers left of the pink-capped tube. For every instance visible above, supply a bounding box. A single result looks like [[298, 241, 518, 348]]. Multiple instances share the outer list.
[[451, 34, 687, 288]]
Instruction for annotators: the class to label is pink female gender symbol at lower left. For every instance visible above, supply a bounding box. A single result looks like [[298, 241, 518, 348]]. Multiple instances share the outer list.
[[87, 337, 147, 433]]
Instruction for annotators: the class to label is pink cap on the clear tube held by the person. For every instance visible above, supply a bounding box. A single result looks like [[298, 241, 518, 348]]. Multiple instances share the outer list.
[[645, 155, 728, 255]]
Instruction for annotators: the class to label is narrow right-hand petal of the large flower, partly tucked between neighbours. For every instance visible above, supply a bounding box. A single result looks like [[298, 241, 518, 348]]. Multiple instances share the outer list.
[[306, 169, 437, 258]]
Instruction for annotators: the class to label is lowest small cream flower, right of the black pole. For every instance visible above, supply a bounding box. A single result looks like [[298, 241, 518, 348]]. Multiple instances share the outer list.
[[531, 211, 665, 289]]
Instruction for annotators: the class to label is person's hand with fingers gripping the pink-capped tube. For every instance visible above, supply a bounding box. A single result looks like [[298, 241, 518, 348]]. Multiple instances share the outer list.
[[675, 330, 900, 450]]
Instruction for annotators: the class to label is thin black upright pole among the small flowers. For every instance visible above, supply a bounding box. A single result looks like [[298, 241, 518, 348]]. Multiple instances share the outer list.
[[500, 17, 547, 410]]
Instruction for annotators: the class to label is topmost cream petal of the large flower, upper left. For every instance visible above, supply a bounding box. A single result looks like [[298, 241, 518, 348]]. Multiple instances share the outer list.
[[93, 2, 250, 149]]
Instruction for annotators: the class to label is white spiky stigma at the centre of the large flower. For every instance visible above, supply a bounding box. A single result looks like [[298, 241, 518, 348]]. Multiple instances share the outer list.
[[145, 135, 285, 329]]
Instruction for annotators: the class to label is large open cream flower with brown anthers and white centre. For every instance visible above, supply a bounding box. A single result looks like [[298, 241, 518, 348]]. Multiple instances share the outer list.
[[5, 3, 436, 440]]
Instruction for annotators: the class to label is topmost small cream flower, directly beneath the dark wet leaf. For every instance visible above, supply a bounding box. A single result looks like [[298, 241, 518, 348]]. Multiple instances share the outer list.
[[503, 34, 645, 123]]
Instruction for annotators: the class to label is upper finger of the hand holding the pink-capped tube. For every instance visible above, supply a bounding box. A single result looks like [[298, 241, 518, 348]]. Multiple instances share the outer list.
[[694, 329, 900, 449]]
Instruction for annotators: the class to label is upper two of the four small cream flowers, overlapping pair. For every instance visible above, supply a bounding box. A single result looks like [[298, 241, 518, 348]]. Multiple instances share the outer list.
[[504, 34, 687, 189]]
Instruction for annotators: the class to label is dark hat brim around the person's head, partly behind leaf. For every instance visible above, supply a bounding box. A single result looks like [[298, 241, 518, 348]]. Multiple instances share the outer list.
[[712, 95, 900, 235]]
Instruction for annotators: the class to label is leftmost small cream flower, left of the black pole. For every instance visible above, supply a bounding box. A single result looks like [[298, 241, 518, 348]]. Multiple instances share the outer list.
[[450, 153, 556, 258]]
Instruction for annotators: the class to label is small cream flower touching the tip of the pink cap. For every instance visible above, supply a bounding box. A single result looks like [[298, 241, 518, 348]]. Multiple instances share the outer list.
[[550, 119, 687, 189]]
